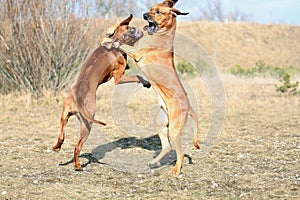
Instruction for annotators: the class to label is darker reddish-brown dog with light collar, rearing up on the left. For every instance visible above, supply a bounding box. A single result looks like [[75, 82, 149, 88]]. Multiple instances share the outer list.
[[53, 15, 150, 171]]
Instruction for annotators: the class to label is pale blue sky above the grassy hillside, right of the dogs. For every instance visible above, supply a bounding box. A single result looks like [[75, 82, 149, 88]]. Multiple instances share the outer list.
[[176, 0, 300, 25]]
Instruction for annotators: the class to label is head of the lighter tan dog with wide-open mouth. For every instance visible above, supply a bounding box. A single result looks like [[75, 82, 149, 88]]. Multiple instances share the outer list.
[[144, 0, 189, 35]]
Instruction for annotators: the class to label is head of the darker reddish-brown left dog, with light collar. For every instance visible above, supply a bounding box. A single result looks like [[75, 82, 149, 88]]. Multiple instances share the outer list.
[[100, 15, 143, 49]]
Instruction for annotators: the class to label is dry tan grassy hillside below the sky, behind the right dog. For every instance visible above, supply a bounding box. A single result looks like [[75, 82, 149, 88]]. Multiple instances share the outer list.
[[178, 21, 300, 70]]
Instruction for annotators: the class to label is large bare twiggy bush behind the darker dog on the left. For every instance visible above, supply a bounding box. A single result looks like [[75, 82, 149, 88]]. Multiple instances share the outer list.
[[0, 0, 98, 97]]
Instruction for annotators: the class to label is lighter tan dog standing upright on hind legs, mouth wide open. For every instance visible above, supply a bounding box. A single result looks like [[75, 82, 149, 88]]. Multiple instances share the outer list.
[[102, 0, 200, 175]]
